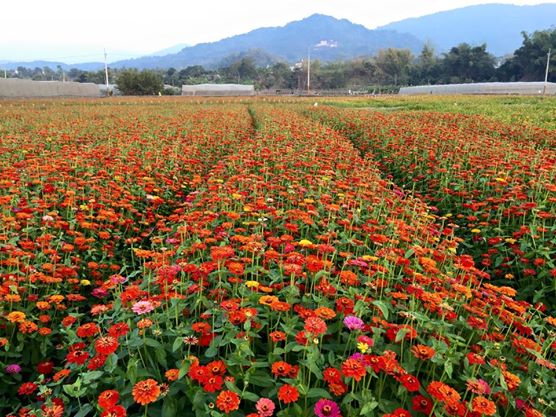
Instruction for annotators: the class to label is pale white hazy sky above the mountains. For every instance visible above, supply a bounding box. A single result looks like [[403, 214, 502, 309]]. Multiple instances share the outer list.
[[0, 0, 554, 63]]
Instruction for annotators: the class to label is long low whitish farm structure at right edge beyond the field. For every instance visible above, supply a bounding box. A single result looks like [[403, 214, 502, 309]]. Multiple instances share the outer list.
[[400, 82, 556, 95]]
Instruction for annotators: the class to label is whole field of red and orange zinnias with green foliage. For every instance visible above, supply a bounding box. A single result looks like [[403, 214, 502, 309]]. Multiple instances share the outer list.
[[0, 99, 556, 417]]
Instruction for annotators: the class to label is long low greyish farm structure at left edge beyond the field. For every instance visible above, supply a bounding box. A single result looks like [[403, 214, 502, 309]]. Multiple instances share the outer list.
[[0, 78, 100, 98]]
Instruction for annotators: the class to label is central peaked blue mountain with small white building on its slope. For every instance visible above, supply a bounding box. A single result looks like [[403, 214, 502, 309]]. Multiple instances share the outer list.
[[111, 14, 422, 68]]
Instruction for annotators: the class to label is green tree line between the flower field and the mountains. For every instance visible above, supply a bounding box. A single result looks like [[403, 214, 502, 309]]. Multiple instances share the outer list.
[[3, 28, 556, 95]]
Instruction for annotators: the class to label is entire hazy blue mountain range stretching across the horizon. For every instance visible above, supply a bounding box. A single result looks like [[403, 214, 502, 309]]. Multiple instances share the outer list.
[[4, 3, 556, 71]]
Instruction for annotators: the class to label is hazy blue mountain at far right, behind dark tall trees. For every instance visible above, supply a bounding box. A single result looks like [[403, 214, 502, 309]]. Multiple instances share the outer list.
[[379, 3, 556, 56]]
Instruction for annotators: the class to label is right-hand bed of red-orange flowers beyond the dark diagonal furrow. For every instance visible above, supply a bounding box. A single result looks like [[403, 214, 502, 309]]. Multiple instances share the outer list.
[[313, 108, 556, 312]]
